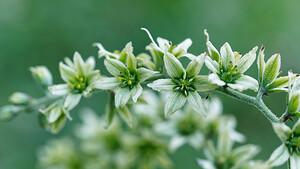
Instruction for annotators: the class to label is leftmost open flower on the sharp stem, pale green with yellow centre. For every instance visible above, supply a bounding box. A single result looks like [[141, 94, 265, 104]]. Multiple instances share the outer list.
[[49, 52, 100, 110]]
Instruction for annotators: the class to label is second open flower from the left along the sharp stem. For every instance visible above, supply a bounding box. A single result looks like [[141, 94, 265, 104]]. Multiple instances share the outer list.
[[93, 42, 157, 108]]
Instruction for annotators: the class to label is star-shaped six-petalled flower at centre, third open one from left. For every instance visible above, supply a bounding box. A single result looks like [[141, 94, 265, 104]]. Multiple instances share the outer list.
[[148, 52, 216, 116]]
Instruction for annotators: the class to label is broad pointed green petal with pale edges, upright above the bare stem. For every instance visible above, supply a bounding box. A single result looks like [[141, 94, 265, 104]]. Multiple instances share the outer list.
[[262, 54, 281, 87]]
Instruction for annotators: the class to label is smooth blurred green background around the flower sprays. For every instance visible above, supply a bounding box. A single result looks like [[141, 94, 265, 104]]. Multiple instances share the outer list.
[[0, 0, 300, 169]]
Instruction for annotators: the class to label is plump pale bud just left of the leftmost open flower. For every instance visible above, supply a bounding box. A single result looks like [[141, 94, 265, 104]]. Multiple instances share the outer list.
[[30, 66, 52, 89]]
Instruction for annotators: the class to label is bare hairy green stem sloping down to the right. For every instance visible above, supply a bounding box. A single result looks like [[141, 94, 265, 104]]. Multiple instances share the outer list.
[[217, 88, 280, 123]]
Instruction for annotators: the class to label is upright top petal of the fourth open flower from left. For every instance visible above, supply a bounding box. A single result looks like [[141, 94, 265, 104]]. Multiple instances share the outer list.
[[220, 42, 235, 70]]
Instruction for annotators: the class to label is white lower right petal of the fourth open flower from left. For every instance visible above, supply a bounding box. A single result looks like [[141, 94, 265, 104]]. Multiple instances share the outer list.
[[227, 75, 258, 92]]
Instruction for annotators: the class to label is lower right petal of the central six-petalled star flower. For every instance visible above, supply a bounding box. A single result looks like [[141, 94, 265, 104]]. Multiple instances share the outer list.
[[187, 92, 206, 116]]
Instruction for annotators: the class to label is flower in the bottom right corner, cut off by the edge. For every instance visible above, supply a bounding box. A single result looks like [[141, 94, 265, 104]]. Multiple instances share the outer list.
[[268, 119, 300, 169]]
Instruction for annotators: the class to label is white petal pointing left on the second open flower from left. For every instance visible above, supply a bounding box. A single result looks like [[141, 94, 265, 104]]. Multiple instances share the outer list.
[[91, 77, 121, 90]]
